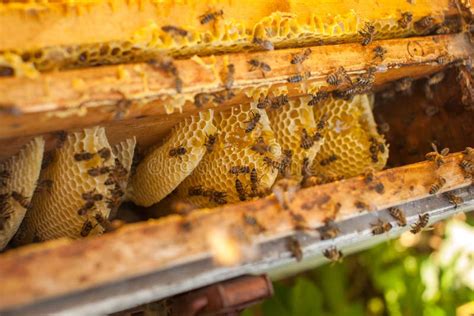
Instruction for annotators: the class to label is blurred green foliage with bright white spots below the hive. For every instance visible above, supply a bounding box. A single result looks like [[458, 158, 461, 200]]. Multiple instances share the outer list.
[[242, 213, 474, 316]]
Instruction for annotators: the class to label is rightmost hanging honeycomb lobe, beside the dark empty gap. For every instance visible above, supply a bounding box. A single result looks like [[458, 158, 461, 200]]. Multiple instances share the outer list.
[[312, 95, 388, 181]]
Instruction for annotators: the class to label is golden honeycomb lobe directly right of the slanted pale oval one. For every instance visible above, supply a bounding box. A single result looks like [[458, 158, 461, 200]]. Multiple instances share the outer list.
[[174, 104, 281, 207]]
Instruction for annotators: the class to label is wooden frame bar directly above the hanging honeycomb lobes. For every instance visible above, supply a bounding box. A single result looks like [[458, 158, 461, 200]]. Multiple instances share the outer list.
[[0, 34, 473, 158]]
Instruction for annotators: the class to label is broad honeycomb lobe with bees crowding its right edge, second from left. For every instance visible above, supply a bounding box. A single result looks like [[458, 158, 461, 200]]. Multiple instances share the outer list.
[[15, 127, 116, 244]]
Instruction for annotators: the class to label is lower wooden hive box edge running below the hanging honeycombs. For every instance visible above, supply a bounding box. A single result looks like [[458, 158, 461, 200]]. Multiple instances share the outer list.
[[0, 153, 471, 310]]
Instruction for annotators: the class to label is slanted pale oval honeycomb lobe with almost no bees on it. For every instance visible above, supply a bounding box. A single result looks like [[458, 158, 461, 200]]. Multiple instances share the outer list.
[[128, 110, 217, 206]]
